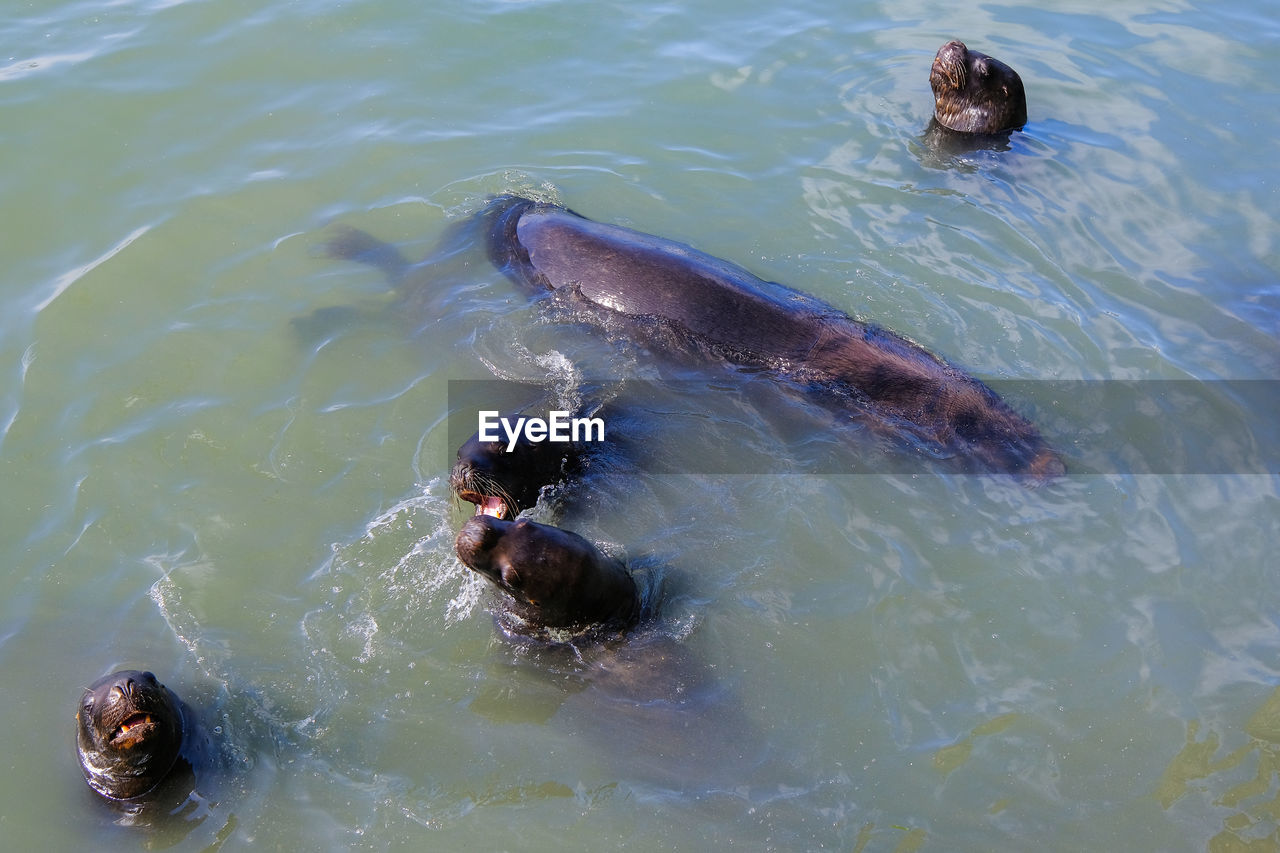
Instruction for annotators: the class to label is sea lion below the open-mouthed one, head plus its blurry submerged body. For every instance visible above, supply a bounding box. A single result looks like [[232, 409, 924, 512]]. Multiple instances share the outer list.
[[458, 515, 803, 808]]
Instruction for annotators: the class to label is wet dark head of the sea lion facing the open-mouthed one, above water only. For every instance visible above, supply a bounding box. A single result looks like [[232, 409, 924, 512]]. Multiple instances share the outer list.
[[454, 515, 643, 635]]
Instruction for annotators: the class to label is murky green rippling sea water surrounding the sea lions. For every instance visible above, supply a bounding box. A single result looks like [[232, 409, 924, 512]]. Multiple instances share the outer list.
[[0, 0, 1280, 853]]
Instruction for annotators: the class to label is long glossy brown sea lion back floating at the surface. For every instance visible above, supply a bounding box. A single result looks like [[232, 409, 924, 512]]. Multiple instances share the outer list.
[[485, 196, 1065, 479]]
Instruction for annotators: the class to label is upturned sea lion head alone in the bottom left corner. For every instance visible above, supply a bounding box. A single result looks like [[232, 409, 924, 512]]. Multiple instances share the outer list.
[[76, 670, 183, 799]]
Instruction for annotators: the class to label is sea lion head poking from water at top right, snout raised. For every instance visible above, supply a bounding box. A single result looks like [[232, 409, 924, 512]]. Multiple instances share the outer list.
[[929, 41, 1027, 133]]
